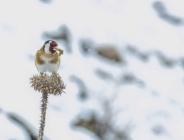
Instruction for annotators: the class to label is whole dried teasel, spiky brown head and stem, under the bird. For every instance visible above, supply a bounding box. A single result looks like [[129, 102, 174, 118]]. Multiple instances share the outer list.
[[30, 73, 65, 140]]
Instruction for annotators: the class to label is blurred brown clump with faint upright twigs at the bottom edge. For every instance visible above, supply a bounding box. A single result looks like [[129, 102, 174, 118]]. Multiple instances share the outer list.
[[73, 96, 130, 140]]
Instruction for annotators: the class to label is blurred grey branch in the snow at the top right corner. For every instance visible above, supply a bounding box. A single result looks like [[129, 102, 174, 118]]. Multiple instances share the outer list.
[[153, 1, 184, 26]]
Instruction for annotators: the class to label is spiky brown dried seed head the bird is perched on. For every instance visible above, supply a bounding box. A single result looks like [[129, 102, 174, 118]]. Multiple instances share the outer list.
[[31, 73, 65, 95]]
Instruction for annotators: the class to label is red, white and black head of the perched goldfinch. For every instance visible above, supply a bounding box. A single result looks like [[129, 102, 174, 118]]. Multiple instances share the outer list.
[[43, 40, 58, 54]]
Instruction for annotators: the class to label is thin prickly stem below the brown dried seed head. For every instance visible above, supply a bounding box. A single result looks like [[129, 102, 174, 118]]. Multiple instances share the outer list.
[[38, 93, 48, 140]]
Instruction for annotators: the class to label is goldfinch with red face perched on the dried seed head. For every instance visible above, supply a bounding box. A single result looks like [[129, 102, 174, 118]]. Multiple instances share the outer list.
[[35, 40, 63, 75]]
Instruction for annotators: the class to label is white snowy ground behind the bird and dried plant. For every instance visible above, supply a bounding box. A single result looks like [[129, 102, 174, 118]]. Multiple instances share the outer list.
[[0, 0, 184, 140]]
